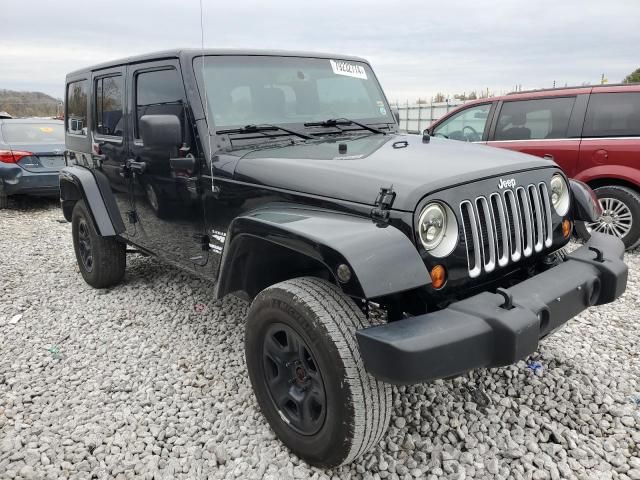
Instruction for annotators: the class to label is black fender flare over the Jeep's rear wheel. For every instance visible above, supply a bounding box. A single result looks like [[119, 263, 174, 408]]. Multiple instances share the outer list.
[[59, 165, 125, 237]]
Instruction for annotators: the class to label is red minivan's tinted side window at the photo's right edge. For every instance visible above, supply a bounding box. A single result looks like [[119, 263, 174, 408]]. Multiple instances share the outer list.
[[582, 92, 640, 137]]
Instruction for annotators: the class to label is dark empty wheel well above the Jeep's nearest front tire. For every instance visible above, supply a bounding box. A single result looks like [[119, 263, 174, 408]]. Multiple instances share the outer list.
[[219, 235, 336, 299]]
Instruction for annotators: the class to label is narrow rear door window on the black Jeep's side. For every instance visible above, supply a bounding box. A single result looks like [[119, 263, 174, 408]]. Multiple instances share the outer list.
[[94, 75, 124, 137]]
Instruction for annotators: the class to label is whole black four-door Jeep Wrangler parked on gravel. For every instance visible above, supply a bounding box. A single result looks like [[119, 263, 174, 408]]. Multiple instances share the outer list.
[[60, 50, 627, 466]]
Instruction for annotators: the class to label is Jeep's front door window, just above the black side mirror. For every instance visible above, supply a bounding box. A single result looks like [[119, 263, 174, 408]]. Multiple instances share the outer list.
[[135, 68, 184, 138]]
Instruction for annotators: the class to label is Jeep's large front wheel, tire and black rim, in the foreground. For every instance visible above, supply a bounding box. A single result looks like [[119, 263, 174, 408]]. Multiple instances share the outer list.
[[245, 277, 392, 467]]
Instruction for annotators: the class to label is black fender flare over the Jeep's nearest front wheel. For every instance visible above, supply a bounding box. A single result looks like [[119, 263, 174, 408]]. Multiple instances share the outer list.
[[216, 206, 431, 299]]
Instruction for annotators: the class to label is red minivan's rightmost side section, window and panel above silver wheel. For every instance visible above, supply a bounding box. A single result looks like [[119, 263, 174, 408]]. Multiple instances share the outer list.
[[579, 89, 640, 183]]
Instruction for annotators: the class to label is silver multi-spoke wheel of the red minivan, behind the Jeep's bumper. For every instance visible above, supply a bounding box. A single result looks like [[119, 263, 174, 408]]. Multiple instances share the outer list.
[[576, 185, 640, 249]]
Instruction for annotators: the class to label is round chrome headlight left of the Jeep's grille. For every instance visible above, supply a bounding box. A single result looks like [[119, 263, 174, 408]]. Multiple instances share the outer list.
[[418, 202, 458, 257]]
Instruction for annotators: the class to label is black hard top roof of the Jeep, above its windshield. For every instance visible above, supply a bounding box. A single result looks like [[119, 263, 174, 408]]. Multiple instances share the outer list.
[[67, 48, 369, 76]]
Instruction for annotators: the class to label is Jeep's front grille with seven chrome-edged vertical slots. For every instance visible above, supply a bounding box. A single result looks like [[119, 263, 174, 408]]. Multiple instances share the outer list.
[[460, 182, 553, 278]]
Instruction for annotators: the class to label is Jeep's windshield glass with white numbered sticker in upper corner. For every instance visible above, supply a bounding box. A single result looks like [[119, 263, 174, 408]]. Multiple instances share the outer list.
[[194, 56, 394, 129]]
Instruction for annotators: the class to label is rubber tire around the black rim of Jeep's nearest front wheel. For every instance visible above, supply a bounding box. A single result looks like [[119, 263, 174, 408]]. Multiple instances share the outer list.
[[245, 277, 392, 467]]
